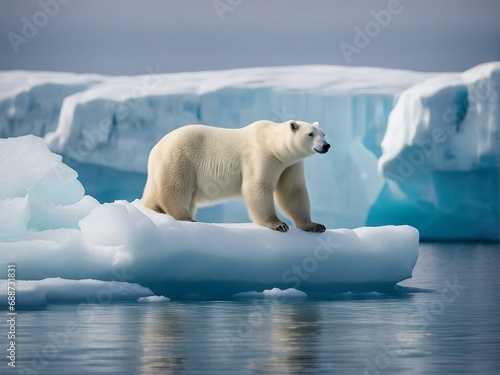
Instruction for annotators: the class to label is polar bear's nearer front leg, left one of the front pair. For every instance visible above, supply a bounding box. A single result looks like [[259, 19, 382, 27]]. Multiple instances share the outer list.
[[242, 182, 288, 232]]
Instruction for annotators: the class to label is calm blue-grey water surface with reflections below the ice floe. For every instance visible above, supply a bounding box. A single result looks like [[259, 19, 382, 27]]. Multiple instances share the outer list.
[[0, 244, 500, 374]]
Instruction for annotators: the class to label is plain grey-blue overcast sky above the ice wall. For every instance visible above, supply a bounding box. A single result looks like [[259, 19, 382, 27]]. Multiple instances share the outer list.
[[0, 0, 500, 75]]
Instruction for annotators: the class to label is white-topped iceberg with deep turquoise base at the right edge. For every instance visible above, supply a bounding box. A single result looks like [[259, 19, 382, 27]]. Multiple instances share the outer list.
[[376, 62, 500, 240]]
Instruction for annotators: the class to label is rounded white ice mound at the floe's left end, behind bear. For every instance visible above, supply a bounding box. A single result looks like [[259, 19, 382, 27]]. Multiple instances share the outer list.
[[0, 135, 99, 238]]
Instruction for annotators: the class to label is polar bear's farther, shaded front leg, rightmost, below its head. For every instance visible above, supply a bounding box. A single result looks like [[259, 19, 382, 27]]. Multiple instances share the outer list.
[[276, 162, 326, 232]]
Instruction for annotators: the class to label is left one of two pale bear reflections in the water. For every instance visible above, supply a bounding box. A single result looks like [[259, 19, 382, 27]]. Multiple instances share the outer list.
[[138, 304, 186, 374]]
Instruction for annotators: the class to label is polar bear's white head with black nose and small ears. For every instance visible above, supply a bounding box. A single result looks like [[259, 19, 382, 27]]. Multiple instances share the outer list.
[[288, 121, 330, 155]]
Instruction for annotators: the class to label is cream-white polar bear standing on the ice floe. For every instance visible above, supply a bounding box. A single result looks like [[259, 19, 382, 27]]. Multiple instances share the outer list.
[[142, 120, 330, 232]]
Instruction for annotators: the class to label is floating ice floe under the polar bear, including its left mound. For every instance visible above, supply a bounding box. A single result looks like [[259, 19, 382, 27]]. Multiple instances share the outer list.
[[0, 135, 419, 307]]
